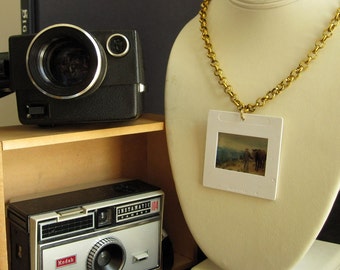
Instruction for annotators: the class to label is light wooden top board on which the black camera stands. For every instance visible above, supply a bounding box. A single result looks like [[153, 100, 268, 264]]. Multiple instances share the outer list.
[[0, 114, 164, 151]]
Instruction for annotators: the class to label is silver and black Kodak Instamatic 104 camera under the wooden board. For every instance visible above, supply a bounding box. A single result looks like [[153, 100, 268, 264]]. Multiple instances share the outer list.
[[7, 180, 164, 270]]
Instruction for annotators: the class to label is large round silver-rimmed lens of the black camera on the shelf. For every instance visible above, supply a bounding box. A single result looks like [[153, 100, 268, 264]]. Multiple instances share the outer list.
[[26, 24, 107, 99]]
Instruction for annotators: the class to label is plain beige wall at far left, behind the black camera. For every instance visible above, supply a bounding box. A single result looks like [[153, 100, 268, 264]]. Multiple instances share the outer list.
[[0, 0, 21, 126]]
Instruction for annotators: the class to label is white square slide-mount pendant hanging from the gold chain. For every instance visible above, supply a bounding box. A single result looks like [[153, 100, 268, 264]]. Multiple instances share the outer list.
[[203, 110, 283, 200]]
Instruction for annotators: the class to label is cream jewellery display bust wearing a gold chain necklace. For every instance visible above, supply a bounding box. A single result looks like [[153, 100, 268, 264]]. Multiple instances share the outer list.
[[165, 0, 340, 270]]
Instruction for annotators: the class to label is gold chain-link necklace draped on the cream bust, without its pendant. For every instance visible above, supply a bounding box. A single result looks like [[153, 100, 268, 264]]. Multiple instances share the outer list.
[[199, 0, 340, 120]]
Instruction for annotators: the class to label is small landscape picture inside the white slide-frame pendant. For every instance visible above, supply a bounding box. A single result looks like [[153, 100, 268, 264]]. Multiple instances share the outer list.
[[215, 132, 268, 176]]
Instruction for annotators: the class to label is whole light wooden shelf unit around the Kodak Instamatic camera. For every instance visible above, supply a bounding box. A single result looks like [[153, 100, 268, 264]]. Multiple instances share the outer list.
[[0, 114, 197, 270]]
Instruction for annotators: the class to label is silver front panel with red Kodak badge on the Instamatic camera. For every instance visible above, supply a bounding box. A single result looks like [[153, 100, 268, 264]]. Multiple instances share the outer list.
[[38, 220, 161, 270]]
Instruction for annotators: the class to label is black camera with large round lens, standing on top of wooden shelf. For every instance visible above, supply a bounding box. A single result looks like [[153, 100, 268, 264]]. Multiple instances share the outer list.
[[9, 24, 145, 125]]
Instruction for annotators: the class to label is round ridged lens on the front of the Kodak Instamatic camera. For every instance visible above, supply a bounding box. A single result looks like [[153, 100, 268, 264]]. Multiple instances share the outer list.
[[87, 237, 125, 270]]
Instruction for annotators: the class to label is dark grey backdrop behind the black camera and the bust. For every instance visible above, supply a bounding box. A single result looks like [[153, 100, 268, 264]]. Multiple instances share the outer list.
[[27, 0, 203, 114]]
